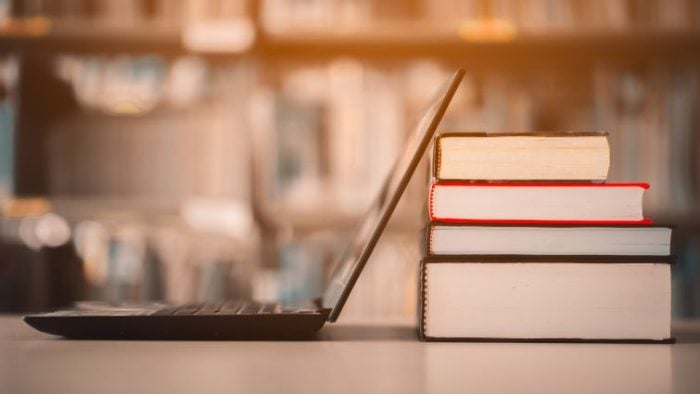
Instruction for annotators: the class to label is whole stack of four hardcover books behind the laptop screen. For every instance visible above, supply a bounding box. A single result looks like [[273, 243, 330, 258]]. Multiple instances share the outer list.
[[420, 133, 672, 342]]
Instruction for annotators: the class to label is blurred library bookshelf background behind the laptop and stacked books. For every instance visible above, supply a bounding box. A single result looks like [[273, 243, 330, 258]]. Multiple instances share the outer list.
[[0, 0, 700, 320]]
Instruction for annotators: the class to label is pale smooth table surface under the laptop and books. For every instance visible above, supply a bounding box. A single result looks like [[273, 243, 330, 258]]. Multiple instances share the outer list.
[[0, 316, 700, 394]]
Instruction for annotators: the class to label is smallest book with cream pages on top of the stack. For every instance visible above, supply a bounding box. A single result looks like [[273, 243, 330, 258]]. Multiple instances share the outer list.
[[433, 132, 610, 182]]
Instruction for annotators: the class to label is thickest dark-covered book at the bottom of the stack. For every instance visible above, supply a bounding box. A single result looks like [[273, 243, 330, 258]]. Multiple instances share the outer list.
[[419, 256, 673, 343]]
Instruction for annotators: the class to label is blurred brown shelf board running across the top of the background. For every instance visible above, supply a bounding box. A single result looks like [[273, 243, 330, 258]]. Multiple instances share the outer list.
[[0, 19, 700, 68]]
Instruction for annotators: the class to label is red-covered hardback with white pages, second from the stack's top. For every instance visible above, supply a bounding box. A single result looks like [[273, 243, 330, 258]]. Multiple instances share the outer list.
[[429, 182, 651, 225]]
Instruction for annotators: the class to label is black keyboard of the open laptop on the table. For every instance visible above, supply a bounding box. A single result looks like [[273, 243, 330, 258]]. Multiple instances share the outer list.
[[37, 300, 319, 316]]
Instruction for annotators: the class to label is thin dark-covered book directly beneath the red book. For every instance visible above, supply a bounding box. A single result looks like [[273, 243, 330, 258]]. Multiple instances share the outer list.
[[427, 222, 672, 256]]
